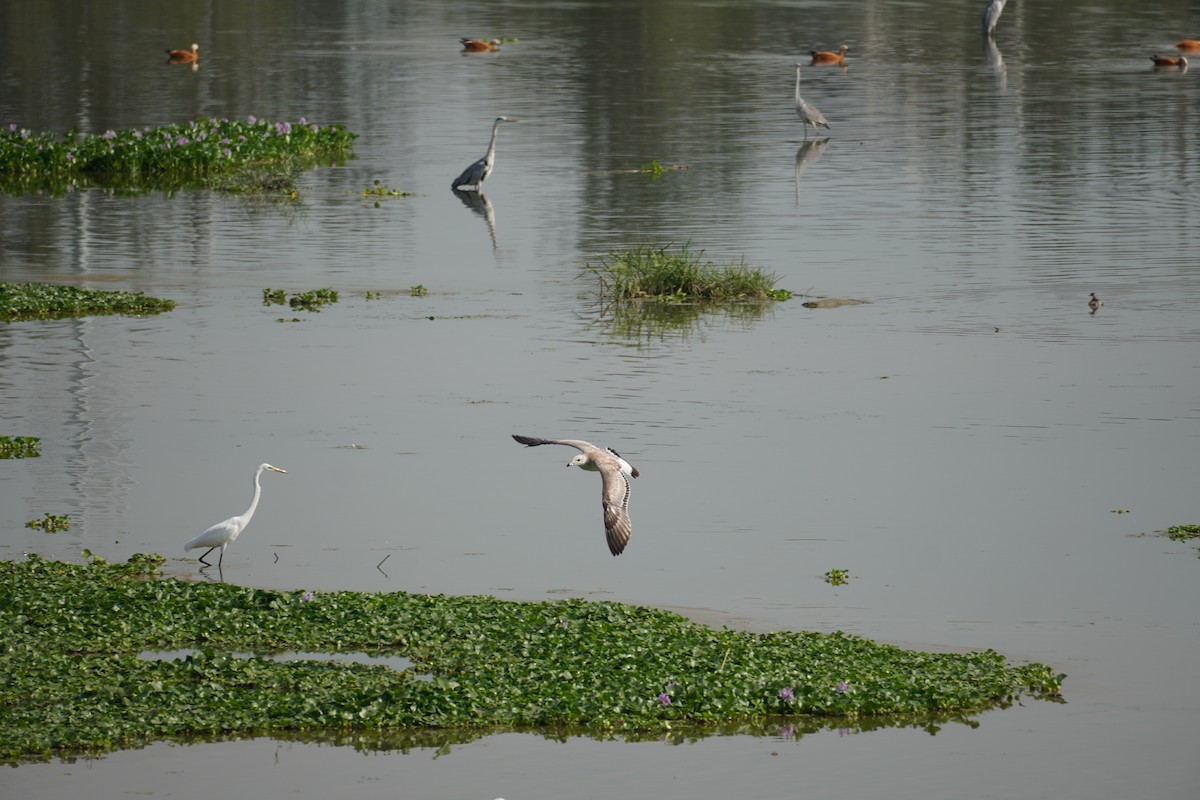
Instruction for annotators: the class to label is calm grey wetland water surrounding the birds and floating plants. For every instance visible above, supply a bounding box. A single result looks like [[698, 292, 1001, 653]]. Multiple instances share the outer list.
[[0, 0, 1200, 799]]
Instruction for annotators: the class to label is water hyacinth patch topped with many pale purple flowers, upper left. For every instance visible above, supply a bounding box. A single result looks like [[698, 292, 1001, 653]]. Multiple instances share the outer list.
[[0, 116, 355, 194]]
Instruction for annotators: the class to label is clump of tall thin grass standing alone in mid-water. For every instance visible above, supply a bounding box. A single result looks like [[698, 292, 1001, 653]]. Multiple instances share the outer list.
[[584, 245, 792, 302]]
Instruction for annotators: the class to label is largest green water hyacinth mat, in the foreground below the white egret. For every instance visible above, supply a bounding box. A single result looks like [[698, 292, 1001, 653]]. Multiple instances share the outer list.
[[0, 555, 1063, 762]]
